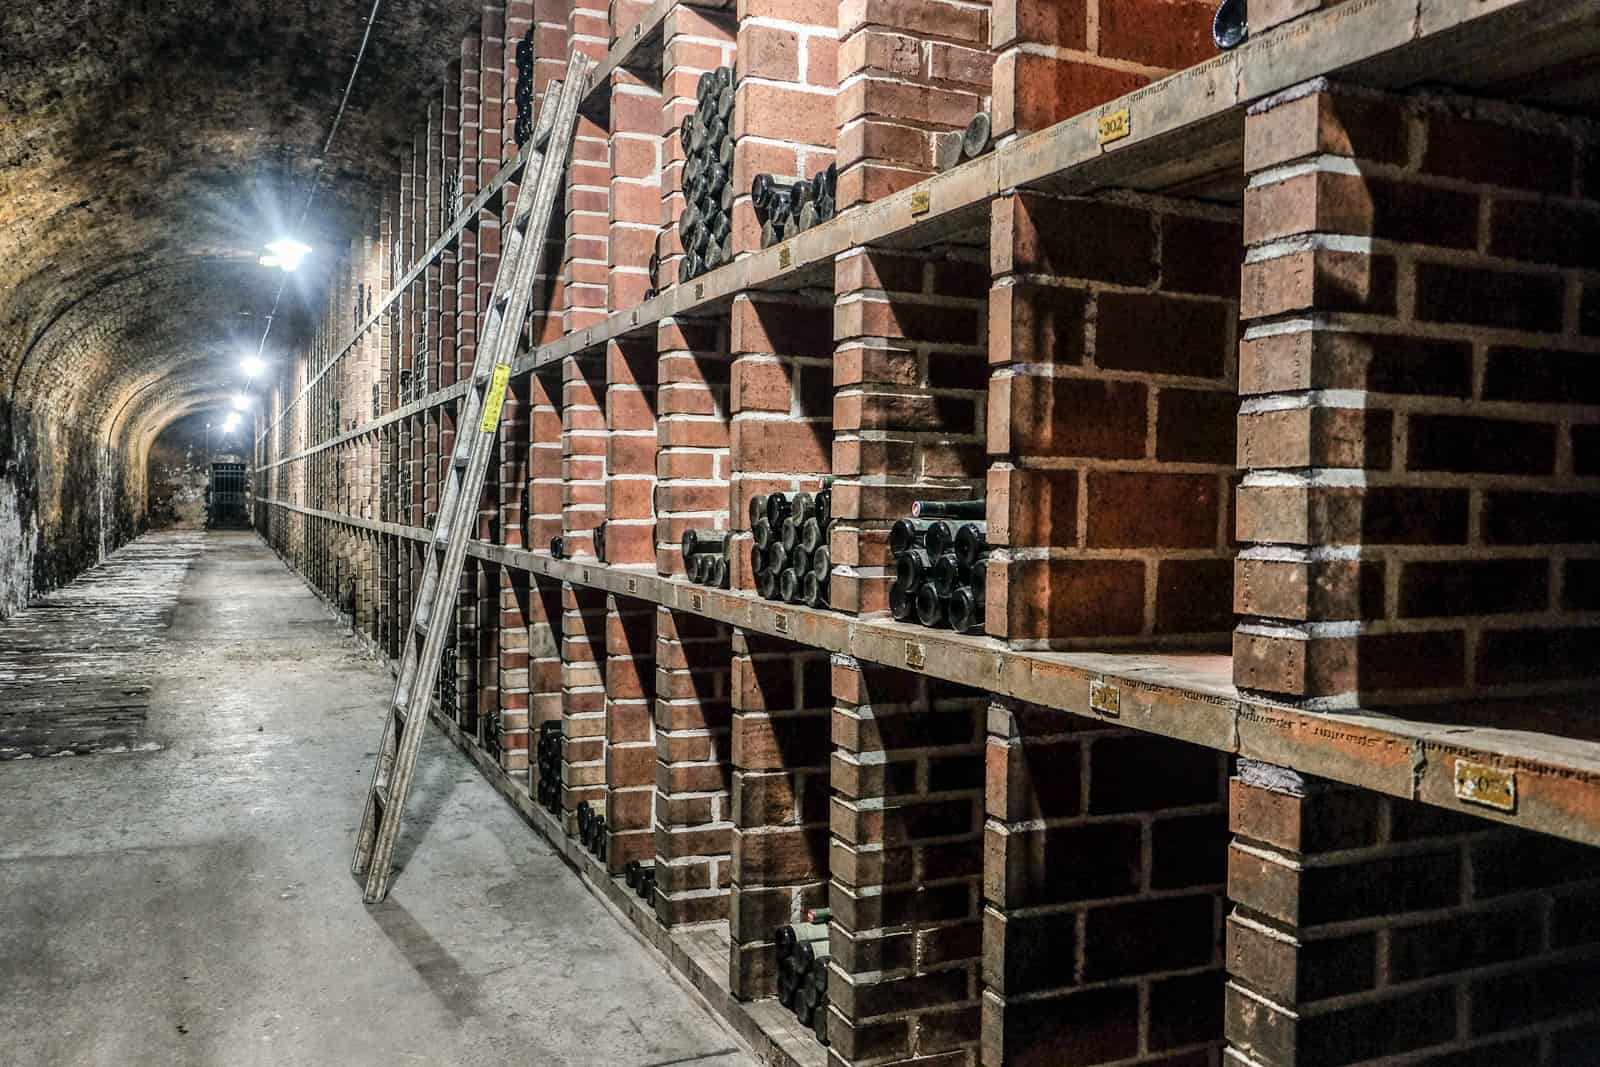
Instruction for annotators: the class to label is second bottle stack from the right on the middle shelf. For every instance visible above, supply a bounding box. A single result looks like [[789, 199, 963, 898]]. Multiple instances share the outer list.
[[750, 486, 834, 608]]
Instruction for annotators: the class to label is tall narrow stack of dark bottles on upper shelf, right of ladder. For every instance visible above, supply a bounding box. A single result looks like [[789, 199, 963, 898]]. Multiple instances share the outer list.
[[678, 67, 733, 282]]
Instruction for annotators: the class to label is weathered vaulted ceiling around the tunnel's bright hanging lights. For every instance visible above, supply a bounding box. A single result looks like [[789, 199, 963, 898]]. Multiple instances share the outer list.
[[0, 0, 478, 444]]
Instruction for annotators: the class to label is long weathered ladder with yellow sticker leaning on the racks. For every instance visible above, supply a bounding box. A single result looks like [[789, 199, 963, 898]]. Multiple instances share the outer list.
[[350, 53, 594, 904]]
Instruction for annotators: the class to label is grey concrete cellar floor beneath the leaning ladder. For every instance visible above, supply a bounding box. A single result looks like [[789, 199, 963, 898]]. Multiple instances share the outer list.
[[0, 533, 754, 1067]]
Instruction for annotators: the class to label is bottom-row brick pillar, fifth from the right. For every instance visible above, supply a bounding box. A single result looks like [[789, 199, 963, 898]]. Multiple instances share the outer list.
[[656, 608, 733, 926]]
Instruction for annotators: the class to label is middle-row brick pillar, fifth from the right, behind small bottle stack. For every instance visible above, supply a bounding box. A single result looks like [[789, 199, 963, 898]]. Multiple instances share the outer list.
[[656, 318, 730, 574]]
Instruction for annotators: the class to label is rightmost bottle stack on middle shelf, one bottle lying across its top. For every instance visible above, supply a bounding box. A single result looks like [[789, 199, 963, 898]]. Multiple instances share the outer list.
[[890, 499, 989, 633]]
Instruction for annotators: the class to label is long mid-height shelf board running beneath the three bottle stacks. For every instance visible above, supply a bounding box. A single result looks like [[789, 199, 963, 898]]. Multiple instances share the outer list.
[[259, 501, 1600, 845]]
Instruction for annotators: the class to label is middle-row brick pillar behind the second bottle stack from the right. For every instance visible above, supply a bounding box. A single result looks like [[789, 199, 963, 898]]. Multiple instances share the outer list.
[[728, 293, 834, 589]]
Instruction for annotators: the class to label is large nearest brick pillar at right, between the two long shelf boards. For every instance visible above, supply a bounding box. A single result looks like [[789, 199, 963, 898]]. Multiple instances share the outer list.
[[1234, 82, 1600, 705]]
